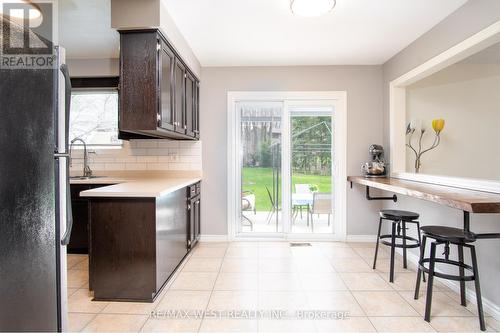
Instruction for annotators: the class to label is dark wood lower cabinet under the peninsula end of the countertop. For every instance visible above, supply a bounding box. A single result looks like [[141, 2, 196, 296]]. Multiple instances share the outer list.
[[90, 188, 188, 302]]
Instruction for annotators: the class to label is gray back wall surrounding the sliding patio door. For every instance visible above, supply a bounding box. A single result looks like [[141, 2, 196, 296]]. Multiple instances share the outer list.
[[200, 66, 383, 235]]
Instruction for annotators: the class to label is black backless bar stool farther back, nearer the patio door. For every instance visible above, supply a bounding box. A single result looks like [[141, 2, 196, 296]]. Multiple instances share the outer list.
[[373, 209, 421, 282]]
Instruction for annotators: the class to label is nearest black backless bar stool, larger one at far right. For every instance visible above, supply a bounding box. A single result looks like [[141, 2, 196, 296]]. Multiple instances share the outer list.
[[415, 226, 486, 331]]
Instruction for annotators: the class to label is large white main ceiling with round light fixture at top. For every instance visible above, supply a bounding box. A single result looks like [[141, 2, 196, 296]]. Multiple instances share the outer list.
[[162, 0, 467, 66]]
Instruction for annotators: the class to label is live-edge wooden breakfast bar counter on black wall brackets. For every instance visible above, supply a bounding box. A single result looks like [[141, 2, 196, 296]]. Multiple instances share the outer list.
[[347, 176, 500, 233]]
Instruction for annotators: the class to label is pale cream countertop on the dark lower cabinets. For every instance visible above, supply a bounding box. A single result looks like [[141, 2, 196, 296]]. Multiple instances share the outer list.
[[70, 172, 201, 198]]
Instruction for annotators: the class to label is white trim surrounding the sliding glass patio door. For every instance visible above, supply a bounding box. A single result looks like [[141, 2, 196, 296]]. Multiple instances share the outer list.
[[227, 91, 347, 241]]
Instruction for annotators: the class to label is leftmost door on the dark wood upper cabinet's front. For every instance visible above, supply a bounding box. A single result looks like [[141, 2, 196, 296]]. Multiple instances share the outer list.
[[158, 41, 175, 130]]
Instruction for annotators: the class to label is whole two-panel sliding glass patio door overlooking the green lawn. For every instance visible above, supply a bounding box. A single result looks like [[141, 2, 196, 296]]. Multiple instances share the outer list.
[[228, 93, 346, 239]]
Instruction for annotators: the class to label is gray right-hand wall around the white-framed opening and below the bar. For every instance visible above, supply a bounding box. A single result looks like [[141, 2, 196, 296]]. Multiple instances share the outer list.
[[383, 0, 500, 305]]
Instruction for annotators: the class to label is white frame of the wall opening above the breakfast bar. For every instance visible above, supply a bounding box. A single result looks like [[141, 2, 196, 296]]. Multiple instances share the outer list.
[[389, 21, 500, 193]]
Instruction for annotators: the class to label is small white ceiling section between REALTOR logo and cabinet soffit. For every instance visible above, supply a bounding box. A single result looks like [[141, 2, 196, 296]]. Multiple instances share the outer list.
[[58, 0, 120, 59]]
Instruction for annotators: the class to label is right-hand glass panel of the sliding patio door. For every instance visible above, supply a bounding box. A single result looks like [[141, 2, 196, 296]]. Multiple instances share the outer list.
[[288, 102, 335, 234]]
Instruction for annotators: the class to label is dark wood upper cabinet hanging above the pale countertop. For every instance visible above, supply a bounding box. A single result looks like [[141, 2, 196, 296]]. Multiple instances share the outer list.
[[118, 29, 199, 140]]
